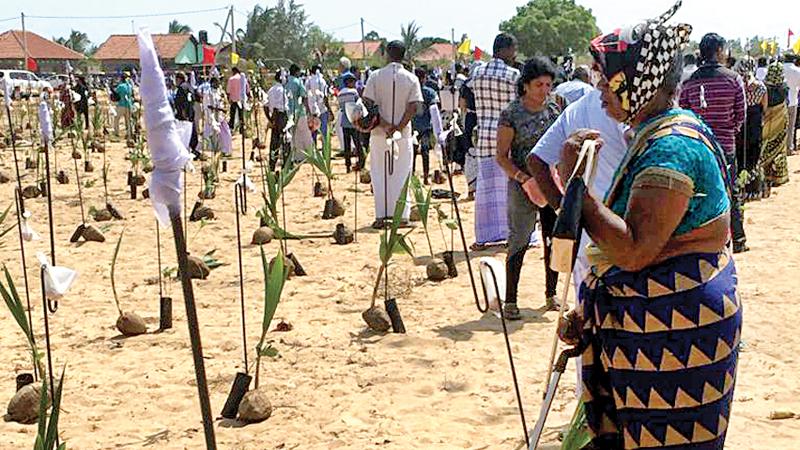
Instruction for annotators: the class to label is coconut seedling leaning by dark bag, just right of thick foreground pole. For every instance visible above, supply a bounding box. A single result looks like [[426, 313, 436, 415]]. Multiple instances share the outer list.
[[239, 247, 289, 423]]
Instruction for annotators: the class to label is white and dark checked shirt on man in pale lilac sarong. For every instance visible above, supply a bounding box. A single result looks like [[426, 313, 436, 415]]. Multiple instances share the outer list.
[[467, 58, 519, 157]]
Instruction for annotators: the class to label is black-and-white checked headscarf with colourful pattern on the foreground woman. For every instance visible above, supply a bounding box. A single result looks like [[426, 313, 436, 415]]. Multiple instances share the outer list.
[[589, 0, 692, 121]]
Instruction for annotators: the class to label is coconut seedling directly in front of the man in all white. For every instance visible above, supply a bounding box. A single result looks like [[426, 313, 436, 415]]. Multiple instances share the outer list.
[[361, 177, 414, 333]]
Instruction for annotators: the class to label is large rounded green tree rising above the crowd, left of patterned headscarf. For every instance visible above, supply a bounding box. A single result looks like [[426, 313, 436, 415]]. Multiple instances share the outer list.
[[500, 0, 600, 56]]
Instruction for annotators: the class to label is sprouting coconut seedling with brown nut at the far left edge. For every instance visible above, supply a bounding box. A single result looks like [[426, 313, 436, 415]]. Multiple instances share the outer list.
[[0, 266, 47, 424]]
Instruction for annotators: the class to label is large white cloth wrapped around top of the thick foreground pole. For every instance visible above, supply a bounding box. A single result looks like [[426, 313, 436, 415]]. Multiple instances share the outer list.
[[137, 28, 192, 226]]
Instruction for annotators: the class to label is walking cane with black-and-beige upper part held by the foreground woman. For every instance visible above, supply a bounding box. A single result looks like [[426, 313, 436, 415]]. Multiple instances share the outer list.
[[528, 140, 597, 450]]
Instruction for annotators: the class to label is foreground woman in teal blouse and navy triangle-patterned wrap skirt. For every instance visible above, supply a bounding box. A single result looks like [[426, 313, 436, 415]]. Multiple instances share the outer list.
[[562, 2, 741, 449]]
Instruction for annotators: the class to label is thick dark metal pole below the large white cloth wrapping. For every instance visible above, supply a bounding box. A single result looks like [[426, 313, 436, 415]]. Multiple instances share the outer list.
[[169, 205, 217, 450]]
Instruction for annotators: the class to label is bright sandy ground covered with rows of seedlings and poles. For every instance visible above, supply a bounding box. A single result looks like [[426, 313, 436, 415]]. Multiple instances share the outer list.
[[0, 127, 800, 450]]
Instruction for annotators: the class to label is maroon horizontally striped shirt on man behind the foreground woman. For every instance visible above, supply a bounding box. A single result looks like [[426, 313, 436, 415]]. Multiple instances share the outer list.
[[680, 64, 745, 154]]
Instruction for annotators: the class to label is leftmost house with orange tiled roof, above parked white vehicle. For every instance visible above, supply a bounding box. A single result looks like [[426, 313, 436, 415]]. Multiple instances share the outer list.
[[0, 30, 86, 72]]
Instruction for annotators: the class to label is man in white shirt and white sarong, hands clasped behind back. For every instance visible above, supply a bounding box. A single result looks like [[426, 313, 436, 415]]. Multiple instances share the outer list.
[[362, 41, 422, 229]]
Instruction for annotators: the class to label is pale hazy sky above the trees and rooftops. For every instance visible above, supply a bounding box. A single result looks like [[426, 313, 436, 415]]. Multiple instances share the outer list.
[[0, 0, 800, 56]]
